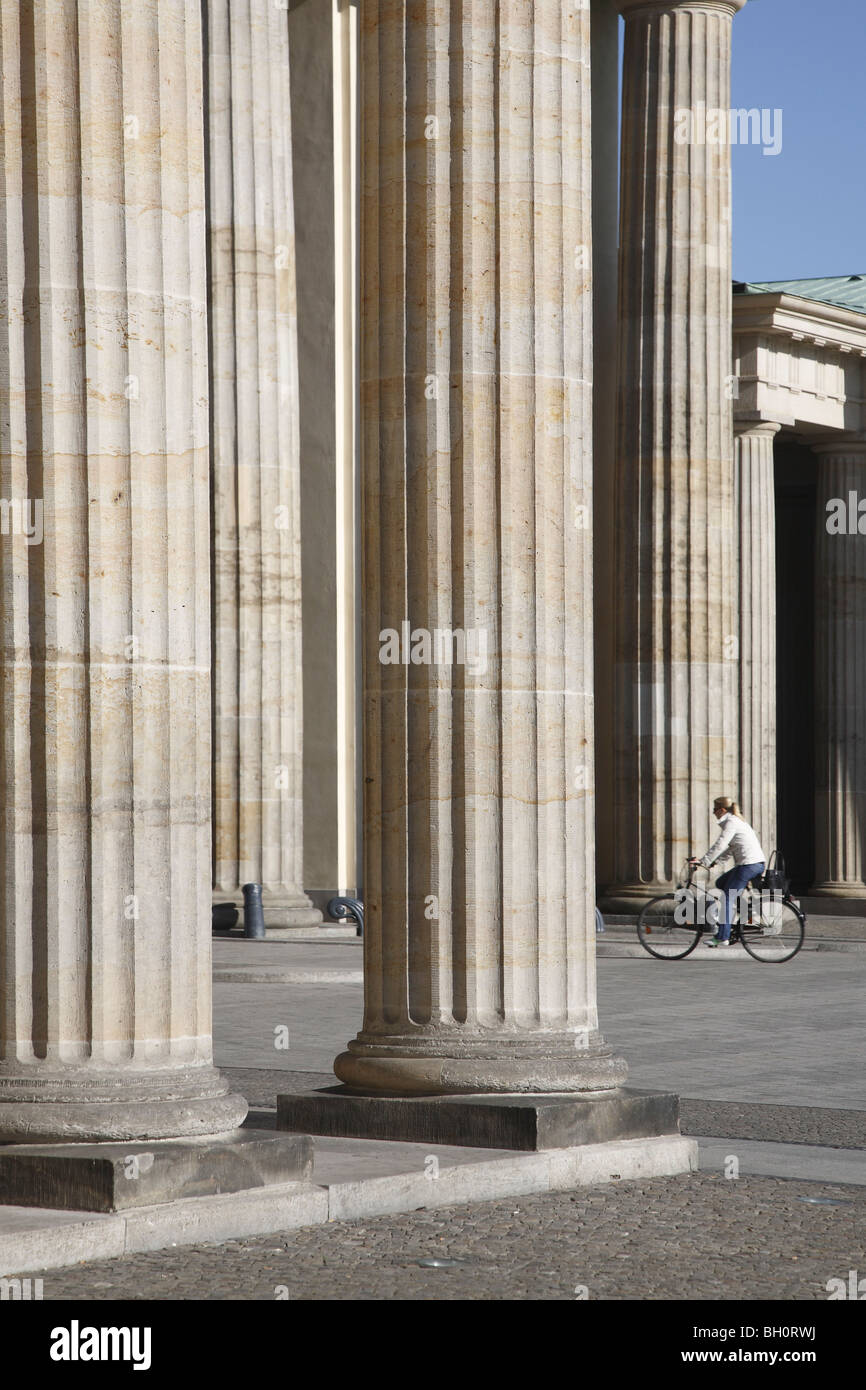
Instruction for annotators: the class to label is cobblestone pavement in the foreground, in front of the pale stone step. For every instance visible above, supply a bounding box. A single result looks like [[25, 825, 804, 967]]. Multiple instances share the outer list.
[[20, 1173, 866, 1301]]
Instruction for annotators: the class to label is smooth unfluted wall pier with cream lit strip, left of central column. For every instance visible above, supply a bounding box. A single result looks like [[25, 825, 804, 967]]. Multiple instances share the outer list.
[[289, 0, 363, 911]]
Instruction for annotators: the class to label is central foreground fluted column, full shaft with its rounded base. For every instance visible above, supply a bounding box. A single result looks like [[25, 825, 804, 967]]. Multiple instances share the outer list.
[[335, 0, 626, 1094]]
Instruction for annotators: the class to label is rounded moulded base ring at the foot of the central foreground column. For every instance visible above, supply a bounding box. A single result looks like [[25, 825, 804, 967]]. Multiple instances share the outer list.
[[334, 1033, 628, 1095]]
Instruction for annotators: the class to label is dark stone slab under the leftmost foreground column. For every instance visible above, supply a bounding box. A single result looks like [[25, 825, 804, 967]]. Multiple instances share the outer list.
[[0, 1129, 313, 1212]]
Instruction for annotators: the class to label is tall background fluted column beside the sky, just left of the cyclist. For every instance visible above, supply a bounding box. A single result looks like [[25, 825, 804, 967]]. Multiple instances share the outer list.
[[609, 0, 745, 901]]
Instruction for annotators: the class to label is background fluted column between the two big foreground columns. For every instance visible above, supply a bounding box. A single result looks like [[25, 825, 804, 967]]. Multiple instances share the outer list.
[[207, 0, 321, 927]]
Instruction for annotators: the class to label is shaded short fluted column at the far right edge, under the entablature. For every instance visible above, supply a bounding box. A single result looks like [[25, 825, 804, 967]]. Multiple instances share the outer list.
[[806, 439, 866, 898]]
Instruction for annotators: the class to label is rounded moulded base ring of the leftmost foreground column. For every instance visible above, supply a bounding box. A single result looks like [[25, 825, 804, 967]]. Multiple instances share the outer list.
[[0, 1066, 249, 1152]]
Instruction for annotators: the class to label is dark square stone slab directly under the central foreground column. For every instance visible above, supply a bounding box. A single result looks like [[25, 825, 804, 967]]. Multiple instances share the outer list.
[[277, 1086, 680, 1152]]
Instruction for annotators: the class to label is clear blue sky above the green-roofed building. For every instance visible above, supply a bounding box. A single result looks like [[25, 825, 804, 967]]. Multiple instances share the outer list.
[[731, 0, 866, 281]]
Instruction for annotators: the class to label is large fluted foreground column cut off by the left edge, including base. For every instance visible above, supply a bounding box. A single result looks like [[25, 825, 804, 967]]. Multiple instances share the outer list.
[[0, 0, 246, 1141]]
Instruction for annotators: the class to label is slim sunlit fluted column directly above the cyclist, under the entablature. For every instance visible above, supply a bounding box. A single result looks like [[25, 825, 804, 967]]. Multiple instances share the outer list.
[[734, 420, 781, 853]]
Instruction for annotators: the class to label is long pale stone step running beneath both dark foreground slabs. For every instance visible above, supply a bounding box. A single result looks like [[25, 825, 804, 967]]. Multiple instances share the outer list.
[[0, 1136, 698, 1273]]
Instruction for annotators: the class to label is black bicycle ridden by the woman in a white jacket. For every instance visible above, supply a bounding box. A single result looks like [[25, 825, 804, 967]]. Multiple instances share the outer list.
[[638, 859, 806, 965]]
